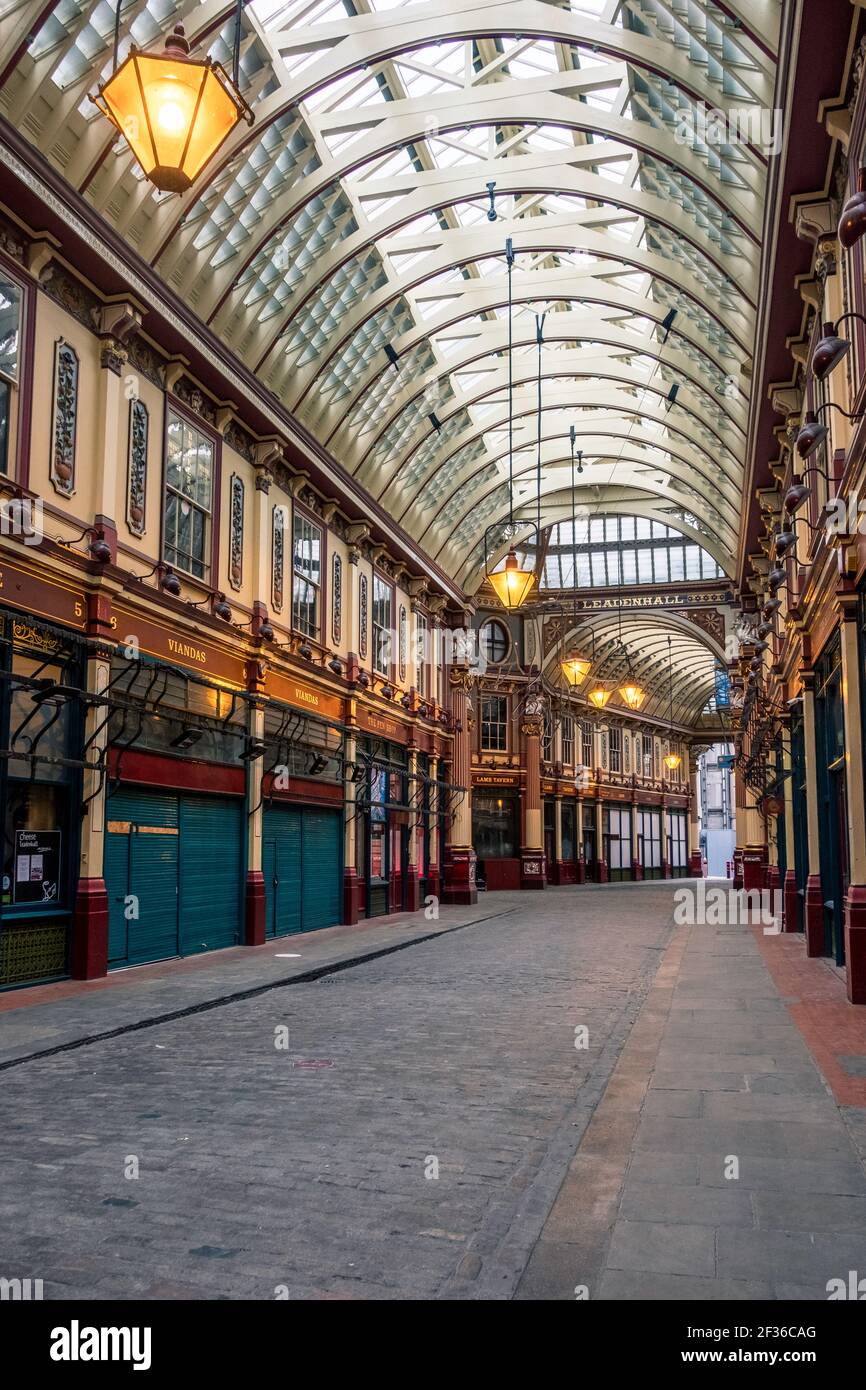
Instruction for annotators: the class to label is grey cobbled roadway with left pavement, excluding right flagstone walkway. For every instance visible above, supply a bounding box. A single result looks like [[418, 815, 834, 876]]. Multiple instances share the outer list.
[[0, 885, 671, 1300]]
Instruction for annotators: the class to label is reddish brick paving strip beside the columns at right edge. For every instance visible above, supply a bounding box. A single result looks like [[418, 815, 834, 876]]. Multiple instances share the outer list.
[[752, 927, 866, 1108]]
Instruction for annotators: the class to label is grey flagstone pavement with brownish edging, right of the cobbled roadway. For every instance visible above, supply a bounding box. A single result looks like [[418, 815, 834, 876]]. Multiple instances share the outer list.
[[518, 906, 866, 1301]]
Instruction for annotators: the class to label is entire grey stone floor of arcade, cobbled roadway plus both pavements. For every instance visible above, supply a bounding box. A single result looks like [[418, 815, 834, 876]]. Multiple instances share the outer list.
[[0, 884, 866, 1300]]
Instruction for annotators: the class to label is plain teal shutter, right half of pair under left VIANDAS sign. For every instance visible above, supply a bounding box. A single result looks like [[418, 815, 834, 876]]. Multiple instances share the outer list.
[[178, 796, 243, 955]]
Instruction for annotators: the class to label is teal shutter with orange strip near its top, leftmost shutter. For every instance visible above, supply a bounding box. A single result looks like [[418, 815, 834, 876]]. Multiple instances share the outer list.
[[104, 788, 178, 966]]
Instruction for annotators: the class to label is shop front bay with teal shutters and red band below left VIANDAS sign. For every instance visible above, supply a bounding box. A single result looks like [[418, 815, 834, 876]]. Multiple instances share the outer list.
[[103, 630, 250, 970]]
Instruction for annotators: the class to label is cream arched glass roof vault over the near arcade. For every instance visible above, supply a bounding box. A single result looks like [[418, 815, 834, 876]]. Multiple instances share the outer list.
[[0, 0, 781, 591]]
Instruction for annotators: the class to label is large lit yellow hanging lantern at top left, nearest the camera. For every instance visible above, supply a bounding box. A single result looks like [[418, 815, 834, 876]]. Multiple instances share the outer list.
[[90, 25, 254, 193]]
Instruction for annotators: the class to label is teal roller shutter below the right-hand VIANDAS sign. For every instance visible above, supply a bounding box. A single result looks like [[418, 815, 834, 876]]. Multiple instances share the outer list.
[[261, 805, 342, 937]]
